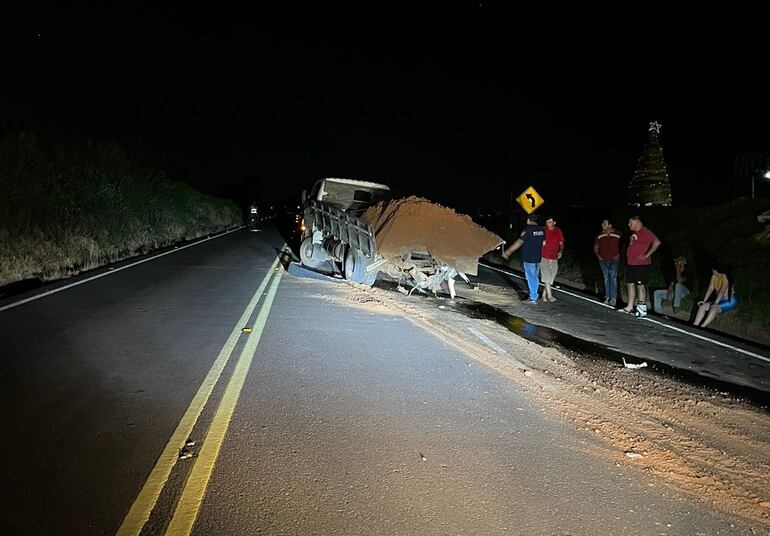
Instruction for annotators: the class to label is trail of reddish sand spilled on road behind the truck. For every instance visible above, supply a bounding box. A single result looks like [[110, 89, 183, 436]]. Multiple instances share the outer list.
[[313, 282, 770, 525]]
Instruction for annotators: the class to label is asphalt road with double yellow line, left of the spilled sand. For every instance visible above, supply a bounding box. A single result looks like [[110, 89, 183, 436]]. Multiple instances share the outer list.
[[0, 229, 746, 535]]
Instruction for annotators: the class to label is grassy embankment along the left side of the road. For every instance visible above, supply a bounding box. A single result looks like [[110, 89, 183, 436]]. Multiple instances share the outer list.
[[0, 133, 242, 286]]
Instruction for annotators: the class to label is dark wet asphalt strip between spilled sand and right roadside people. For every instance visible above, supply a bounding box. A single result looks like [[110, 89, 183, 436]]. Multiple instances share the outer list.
[[468, 264, 770, 398]]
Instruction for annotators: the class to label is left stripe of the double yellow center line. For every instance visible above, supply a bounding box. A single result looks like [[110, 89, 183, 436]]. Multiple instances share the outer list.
[[116, 252, 283, 536]]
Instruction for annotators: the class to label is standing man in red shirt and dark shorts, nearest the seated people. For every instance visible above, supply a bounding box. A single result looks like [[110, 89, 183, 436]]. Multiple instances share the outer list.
[[618, 216, 660, 318]]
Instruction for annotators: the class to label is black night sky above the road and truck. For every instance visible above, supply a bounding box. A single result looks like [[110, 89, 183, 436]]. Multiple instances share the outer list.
[[6, 2, 770, 212]]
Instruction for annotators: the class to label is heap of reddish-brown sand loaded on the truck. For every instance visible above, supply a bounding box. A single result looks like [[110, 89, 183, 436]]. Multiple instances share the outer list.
[[361, 196, 503, 275]]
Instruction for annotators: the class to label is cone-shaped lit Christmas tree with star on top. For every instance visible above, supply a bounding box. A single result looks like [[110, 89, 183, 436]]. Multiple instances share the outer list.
[[628, 121, 671, 207]]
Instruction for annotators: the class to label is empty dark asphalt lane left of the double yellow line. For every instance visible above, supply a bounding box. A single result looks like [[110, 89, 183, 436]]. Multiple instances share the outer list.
[[0, 231, 281, 535]]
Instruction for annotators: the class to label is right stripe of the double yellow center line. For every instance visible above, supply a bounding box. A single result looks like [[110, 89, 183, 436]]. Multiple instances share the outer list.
[[165, 272, 281, 536]]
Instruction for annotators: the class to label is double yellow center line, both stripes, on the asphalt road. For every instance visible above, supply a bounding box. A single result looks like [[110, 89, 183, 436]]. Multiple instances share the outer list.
[[117, 252, 283, 536]]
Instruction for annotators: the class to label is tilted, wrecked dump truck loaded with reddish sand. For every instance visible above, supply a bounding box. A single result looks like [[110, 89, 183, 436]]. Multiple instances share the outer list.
[[299, 178, 503, 297]]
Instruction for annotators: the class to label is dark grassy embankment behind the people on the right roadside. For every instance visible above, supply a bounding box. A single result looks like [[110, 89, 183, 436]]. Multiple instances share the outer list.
[[492, 199, 770, 344]]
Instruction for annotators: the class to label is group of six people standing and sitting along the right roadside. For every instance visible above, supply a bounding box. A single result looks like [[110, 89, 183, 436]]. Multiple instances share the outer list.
[[502, 214, 738, 327]]
